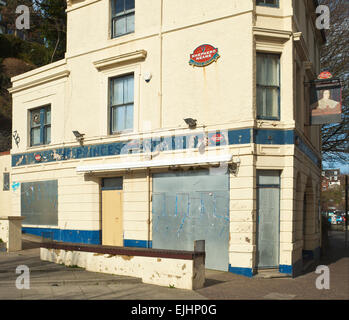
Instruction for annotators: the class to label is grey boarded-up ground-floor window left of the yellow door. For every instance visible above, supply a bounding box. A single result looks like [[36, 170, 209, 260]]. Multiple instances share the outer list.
[[21, 180, 58, 226]]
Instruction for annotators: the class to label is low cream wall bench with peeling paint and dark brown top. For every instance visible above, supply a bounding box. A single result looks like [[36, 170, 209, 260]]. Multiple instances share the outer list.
[[40, 242, 205, 290]]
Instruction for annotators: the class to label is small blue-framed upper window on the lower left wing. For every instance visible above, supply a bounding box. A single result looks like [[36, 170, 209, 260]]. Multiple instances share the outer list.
[[30, 105, 51, 146]]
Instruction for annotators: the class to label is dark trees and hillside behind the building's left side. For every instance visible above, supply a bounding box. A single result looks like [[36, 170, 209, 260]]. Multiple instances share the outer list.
[[0, 0, 66, 152]]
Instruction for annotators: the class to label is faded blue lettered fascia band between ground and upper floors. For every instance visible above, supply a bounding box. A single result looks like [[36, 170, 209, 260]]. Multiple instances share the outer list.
[[12, 128, 320, 167]]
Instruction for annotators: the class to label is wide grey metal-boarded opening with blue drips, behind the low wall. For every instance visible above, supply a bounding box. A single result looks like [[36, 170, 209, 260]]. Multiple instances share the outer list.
[[153, 170, 229, 271]]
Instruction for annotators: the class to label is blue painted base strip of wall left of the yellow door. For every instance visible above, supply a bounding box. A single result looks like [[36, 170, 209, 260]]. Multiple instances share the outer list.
[[22, 227, 101, 244]]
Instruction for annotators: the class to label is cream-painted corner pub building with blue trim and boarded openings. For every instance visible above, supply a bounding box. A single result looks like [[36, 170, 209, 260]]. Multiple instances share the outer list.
[[6, 0, 324, 276]]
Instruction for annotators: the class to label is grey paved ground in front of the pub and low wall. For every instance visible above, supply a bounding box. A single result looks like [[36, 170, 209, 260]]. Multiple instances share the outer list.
[[0, 231, 349, 300]]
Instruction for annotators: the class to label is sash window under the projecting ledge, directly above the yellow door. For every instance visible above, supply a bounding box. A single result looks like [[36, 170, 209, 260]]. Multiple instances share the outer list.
[[110, 74, 134, 134]]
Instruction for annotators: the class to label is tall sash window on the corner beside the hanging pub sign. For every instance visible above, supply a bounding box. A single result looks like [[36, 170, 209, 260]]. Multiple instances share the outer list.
[[257, 53, 280, 120]]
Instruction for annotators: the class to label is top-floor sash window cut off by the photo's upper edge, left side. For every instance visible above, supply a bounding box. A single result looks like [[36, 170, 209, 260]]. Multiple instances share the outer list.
[[111, 0, 135, 38]]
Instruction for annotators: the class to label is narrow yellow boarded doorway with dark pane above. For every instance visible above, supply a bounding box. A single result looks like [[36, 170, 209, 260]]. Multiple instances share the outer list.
[[102, 178, 124, 246]]
